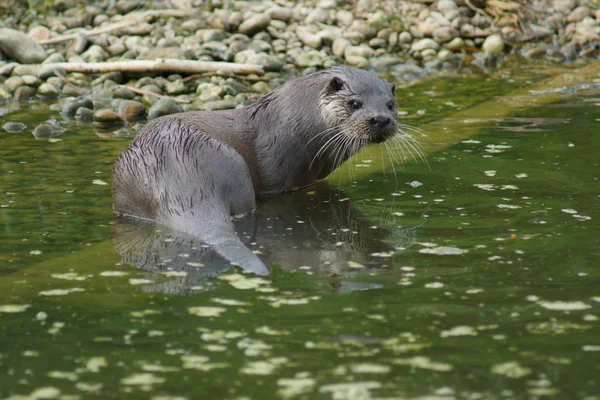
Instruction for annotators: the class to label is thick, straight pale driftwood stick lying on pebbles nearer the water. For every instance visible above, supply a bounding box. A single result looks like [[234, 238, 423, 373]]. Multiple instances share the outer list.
[[42, 59, 264, 75]]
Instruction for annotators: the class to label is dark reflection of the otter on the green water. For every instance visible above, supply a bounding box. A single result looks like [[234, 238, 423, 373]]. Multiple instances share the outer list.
[[113, 182, 413, 291]]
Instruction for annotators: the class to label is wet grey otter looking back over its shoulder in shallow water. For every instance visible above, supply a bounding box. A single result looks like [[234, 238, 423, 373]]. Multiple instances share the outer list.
[[112, 66, 398, 274]]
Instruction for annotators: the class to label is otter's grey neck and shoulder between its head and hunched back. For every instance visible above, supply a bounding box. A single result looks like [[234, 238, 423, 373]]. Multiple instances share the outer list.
[[245, 73, 350, 194]]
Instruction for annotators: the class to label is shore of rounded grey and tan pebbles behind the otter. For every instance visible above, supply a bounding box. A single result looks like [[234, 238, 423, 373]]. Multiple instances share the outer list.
[[0, 0, 600, 131]]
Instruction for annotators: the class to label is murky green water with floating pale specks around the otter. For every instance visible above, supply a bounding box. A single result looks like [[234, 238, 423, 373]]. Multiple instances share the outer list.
[[0, 66, 600, 400]]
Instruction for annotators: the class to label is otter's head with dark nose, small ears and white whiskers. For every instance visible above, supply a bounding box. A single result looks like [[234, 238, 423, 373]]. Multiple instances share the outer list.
[[319, 67, 398, 147]]
